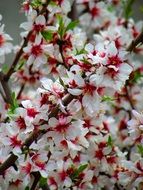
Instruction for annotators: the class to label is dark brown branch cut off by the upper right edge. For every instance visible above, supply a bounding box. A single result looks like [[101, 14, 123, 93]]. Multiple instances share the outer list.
[[126, 31, 143, 52]]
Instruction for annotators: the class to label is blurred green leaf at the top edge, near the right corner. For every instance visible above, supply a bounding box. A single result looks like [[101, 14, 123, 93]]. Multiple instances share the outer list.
[[122, 0, 135, 20]]
